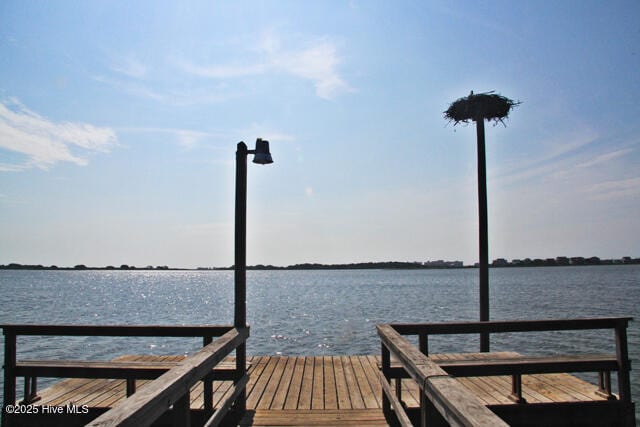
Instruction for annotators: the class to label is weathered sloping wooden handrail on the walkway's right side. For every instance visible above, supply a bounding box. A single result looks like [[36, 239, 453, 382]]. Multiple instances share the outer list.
[[376, 325, 507, 427]]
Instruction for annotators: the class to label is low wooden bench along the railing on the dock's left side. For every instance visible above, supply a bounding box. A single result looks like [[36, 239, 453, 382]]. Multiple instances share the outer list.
[[15, 356, 249, 404]]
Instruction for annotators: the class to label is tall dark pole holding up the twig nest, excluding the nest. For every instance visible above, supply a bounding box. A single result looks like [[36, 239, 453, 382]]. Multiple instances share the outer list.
[[476, 117, 489, 352]]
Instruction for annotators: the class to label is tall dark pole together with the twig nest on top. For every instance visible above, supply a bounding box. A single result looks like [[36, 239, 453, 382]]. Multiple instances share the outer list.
[[444, 91, 520, 352]]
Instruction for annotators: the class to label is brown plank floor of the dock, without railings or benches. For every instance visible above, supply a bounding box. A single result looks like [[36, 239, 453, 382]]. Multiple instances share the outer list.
[[20, 353, 606, 426]]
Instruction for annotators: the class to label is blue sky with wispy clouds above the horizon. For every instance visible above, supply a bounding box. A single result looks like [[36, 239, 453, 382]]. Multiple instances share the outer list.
[[0, 0, 640, 267]]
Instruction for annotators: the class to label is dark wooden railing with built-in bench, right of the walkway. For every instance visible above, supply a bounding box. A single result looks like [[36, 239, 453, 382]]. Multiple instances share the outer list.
[[377, 317, 635, 425]]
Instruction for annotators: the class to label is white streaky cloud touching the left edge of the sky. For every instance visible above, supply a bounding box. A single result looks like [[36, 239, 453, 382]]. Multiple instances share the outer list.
[[0, 99, 118, 172]]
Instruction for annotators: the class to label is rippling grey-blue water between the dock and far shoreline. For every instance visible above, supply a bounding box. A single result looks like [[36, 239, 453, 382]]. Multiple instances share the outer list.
[[0, 266, 640, 419]]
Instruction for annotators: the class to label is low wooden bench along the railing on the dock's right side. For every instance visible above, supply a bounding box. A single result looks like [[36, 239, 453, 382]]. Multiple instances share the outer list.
[[379, 352, 618, 403]]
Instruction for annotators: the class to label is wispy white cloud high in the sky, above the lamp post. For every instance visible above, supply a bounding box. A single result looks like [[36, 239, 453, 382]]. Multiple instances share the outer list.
[[175, 33, 353, 99]]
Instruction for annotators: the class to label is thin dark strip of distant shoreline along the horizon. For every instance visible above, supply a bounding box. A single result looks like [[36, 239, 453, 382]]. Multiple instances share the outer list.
[[0, 257, 640, 271]]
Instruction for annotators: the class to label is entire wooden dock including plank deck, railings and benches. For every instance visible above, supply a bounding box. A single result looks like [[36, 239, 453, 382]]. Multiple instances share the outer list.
[[2, 318, 636, 427]]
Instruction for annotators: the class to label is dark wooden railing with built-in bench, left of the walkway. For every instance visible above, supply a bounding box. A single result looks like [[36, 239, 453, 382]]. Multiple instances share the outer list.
[[0, 324, 249, 426]]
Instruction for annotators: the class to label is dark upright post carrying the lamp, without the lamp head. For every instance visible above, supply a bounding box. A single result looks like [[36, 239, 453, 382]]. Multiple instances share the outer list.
[[233, 142, 248, 411]]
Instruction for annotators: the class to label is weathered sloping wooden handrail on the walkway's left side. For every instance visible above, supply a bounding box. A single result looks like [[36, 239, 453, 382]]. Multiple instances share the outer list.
[[87, 328, 249, 427]]
